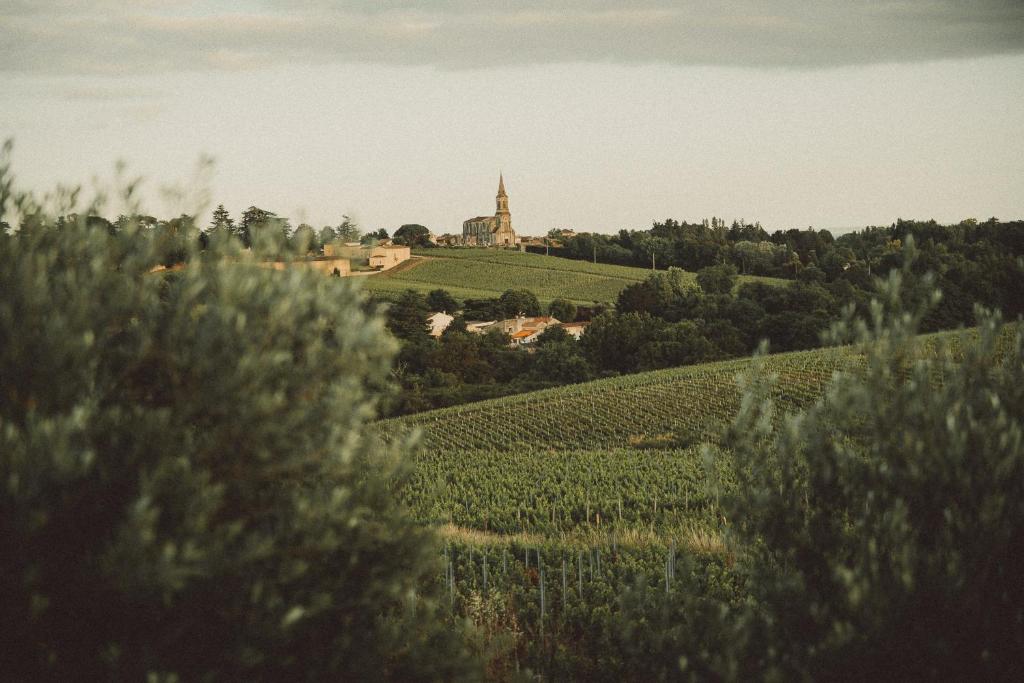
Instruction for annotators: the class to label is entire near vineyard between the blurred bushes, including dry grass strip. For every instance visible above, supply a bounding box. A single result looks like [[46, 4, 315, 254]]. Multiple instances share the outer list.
[[378, 327, 1014, 678]]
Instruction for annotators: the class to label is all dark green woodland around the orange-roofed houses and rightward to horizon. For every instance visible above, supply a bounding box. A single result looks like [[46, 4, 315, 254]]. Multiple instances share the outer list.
[[388, 219, 1024, 415]]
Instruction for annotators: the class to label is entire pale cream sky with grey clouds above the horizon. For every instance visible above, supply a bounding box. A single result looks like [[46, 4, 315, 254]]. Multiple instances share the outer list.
[[0, 0, 1024, 234]]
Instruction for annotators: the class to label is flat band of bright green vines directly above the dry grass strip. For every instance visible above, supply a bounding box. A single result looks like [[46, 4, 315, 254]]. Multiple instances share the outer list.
[[406, 446, 730, 537]]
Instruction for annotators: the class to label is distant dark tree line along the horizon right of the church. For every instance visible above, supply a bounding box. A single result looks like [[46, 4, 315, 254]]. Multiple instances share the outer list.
[[529, 218, 1024, 319]]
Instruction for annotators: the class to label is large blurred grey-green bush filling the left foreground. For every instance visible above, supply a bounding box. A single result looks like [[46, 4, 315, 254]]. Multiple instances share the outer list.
[[0, 192, 482, 680]]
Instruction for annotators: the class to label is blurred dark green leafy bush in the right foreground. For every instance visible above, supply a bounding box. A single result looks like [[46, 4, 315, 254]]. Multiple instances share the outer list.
[[711, 268, 1024, 680]]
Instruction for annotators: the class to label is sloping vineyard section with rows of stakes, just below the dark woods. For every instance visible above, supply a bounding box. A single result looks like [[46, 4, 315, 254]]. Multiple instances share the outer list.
[[380, 349, 857, 452]]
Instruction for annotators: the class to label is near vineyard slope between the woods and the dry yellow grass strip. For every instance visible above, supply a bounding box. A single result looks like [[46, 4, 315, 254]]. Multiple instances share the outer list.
[[387, 327, 1013, 552]]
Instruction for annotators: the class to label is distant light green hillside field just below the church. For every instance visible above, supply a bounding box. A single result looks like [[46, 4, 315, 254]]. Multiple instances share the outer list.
[[364, 249, 780, 304]]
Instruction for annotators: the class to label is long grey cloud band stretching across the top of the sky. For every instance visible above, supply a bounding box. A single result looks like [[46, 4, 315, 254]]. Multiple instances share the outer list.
[[6, 0, 1024, 75]]
